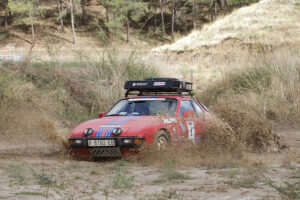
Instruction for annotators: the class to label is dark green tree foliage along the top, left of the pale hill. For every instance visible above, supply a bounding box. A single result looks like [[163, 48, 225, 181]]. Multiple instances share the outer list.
[[0, 0, 258, 41]]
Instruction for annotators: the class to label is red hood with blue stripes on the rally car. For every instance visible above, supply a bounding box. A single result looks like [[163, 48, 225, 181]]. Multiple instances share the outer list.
[[71, 116, 172, 137]]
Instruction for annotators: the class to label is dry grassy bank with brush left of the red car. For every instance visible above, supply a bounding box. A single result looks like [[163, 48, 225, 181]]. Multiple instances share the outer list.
[[0, 52, 157, 158]]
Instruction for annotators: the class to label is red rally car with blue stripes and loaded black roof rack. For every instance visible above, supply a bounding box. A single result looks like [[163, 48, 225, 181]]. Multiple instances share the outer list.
[[69, 78, 209, 157]]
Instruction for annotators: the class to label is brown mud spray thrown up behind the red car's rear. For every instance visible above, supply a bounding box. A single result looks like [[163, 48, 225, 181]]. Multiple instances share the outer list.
[[211, 99, 282, 152]]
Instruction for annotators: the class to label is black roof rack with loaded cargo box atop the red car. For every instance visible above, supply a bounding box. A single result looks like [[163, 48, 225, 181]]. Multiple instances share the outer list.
[[124, 78, 193, 97]]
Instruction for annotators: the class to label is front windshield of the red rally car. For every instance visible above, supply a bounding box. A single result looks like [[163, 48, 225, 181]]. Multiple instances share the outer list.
[[106, 98, 177, 116]]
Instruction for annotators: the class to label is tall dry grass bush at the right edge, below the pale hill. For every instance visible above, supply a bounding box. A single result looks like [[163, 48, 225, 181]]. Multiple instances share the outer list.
[[198, 47, 300, 121]]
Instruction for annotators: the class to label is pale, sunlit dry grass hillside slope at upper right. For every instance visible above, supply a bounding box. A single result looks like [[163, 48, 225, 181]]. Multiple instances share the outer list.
[[153, 0, 300, 52]]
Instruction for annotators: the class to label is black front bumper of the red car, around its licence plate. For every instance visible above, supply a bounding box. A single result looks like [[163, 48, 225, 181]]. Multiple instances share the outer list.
[[69, 137, 145, 149]]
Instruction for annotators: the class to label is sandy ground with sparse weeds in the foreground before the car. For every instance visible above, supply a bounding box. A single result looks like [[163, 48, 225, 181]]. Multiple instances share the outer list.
[[0, 130, 300, 200]]
